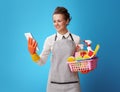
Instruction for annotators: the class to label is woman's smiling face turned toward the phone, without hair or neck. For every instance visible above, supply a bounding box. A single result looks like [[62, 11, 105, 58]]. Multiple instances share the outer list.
[[53, 14, 68, 32]]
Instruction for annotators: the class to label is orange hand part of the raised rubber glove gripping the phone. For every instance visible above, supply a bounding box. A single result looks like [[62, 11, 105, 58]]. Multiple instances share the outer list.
[[28, 38, 37, 55]]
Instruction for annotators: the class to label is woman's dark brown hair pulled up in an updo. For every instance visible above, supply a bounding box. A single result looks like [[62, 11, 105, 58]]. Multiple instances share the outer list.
[[53, 7, 71, 22]]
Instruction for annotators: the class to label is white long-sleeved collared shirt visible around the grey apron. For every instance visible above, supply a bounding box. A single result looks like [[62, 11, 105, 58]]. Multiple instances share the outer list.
[[38, 32, 80, 65]]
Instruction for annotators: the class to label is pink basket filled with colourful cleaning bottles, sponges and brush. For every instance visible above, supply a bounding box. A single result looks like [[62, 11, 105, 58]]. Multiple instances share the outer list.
[[67, 40, 100, 74]]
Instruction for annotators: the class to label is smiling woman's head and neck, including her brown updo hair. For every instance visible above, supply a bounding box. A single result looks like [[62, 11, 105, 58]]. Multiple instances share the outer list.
[[53, 7, 71, 34]]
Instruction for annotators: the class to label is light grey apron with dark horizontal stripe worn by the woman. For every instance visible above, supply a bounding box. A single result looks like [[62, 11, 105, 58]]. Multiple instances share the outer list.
[[47, 34, 80, 92]]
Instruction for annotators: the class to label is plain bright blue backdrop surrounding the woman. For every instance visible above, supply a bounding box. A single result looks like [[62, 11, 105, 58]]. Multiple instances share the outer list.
[[0, 0, 120, 92]]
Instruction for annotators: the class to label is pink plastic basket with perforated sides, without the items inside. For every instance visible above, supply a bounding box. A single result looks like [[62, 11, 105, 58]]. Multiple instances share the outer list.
[[67, 57, 98, 74]]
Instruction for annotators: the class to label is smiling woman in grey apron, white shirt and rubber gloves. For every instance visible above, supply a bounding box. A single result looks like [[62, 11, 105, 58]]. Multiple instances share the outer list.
[[28, 7, 80, 92]]
